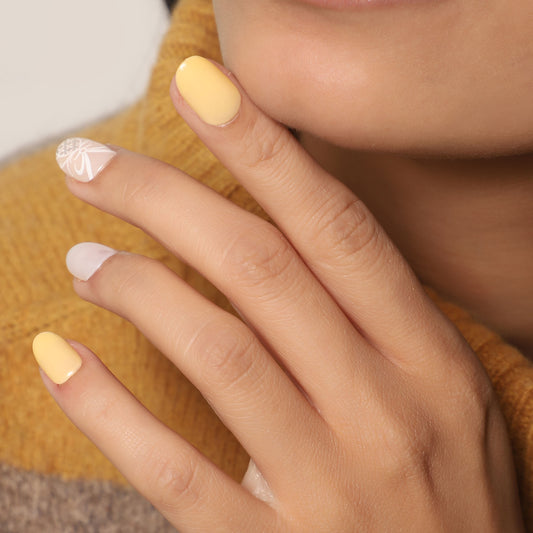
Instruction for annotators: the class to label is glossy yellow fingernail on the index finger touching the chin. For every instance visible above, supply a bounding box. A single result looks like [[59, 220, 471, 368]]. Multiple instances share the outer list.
[[176, 56, 241, 126]]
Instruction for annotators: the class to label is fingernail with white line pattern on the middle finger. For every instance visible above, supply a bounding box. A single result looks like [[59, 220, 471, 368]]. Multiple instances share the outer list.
[[56, 137, 117, 182]]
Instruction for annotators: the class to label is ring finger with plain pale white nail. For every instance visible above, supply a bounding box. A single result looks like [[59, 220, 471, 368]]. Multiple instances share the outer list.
[[68, 243, 326, 490]]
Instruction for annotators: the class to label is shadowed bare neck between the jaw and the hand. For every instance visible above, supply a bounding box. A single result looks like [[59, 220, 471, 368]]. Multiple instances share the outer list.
[[301, 134, 533, 358]]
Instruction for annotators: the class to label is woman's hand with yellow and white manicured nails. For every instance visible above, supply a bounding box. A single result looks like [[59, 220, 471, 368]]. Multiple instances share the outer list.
[[37, 56, 522, 532]]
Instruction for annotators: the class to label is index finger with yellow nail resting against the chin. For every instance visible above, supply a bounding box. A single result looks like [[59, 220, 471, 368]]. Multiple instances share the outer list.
[[171, 57, 455, 361]]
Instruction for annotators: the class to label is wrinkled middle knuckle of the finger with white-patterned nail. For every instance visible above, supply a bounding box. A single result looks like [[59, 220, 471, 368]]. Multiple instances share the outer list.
[[222, 226, 296, 288]]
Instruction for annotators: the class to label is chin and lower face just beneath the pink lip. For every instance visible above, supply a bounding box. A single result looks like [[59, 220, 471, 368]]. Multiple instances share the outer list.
[[214, 0, 533, 156]]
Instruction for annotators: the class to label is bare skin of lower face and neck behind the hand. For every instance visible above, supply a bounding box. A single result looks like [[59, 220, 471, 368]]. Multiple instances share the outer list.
[[214, 0, 533, 357]]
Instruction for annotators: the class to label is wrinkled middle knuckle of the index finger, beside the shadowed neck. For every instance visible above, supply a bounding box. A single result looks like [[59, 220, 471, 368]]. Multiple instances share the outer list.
[[312, 196, 379, 257]]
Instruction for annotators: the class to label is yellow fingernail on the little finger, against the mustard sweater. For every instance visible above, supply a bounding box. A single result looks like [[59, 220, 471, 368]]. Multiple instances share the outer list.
[[32, 331, 81, 385]]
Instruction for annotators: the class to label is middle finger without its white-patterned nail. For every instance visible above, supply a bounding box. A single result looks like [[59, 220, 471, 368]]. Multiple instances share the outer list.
[[59, 142, 380, 411]]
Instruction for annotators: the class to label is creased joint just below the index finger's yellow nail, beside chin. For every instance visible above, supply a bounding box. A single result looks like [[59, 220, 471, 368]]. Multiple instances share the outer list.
[[241, 114, 288, 169]]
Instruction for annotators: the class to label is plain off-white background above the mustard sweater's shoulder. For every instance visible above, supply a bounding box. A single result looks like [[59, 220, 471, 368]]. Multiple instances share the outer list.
[[0, 0, 169, 163]]
